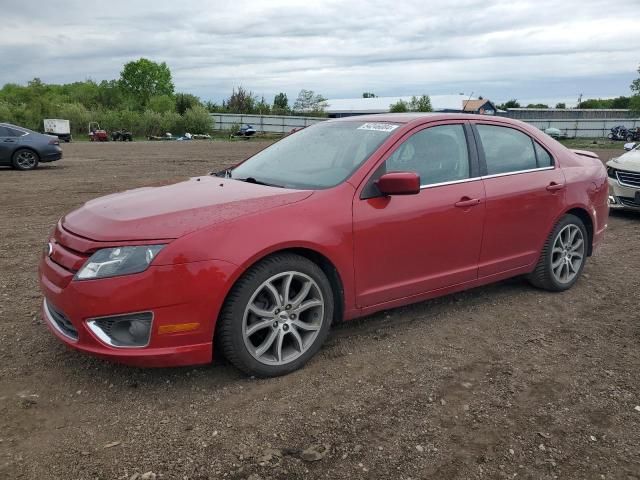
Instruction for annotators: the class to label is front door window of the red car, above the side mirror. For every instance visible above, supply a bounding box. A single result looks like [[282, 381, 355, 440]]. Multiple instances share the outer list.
[[385, 125, 469, 185]]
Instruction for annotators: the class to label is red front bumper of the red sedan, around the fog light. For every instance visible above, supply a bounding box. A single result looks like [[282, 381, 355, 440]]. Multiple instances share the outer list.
[[39, 251, 236, 367]]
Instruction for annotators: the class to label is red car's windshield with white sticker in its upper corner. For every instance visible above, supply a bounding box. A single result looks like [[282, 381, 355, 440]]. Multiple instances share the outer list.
[[231, 121, 399, 189]]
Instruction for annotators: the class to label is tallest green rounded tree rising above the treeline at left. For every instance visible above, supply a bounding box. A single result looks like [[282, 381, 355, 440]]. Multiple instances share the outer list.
[[120, 58, 174, 107]]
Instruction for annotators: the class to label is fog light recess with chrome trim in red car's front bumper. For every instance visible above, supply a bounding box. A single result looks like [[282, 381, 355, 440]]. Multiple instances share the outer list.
[[87, 312, 153, 348]]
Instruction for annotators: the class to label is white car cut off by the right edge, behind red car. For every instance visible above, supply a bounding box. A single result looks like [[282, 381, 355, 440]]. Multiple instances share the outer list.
[[607, 143, 640, 212]]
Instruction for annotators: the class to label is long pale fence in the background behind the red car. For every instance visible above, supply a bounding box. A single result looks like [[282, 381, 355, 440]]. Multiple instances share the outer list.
[[211, 113, 640, 138]]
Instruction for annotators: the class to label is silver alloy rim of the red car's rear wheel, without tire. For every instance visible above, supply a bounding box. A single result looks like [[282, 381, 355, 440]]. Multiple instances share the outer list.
[[551, 224, 585, 284]]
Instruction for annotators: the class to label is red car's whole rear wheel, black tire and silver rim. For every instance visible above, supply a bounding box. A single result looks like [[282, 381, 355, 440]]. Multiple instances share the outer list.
[[527, 214, 589, 292]]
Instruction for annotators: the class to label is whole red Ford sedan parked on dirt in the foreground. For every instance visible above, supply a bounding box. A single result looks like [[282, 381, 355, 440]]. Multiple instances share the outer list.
[[39, 114, 608, 377]]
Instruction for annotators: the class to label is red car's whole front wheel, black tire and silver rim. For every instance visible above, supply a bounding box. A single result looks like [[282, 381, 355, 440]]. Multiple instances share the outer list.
[[216, 253, 334, 377]]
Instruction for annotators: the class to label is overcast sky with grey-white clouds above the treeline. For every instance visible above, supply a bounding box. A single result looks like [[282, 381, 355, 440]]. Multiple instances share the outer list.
[[0, 0, 640, 103]]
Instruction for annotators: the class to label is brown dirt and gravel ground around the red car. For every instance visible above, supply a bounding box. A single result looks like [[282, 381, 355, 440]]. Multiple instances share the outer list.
[[0, 142, 640, 480]]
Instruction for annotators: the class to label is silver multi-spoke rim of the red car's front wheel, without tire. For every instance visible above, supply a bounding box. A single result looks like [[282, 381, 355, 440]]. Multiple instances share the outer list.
[[242, 271, 325, 365]]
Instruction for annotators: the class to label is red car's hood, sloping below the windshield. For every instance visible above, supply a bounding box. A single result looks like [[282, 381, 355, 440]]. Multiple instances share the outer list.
[[62, 176, 313, 242]]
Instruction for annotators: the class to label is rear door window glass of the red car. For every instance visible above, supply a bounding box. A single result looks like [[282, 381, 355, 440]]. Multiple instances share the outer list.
[[476, 125, 536, 175]]
